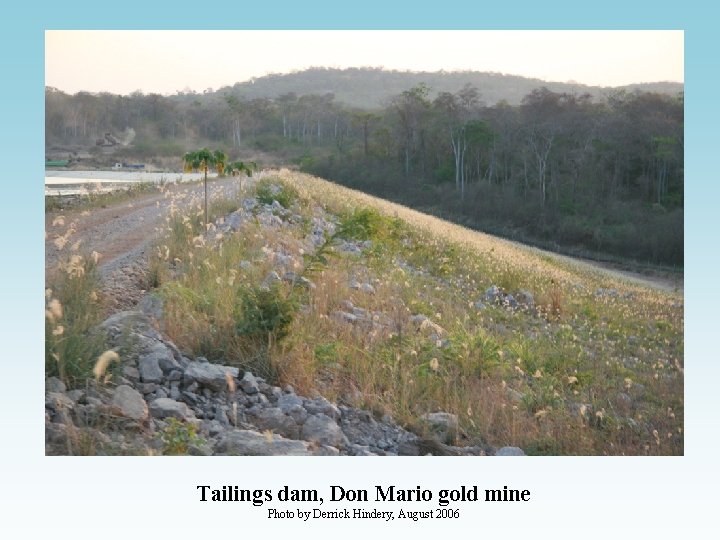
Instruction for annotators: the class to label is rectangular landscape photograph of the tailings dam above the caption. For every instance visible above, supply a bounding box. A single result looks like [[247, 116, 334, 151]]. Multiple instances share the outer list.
[[45, 29, 685, 456]]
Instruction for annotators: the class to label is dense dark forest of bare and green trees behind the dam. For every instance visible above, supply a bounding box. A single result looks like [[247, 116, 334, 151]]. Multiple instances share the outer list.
[[45, 70, 684, 266]]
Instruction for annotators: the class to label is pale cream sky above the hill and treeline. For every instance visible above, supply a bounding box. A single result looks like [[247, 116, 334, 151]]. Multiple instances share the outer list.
[[45, 30, 684, 94]]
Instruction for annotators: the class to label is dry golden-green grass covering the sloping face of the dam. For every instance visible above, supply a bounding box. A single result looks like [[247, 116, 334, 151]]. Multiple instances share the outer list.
[[94, 171, 684, 455]]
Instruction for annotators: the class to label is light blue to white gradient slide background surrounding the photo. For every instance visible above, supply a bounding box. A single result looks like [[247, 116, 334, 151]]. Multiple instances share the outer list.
[[0, 0, 720, 538]]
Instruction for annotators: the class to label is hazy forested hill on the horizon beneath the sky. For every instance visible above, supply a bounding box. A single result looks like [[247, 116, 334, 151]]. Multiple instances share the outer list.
[[205, 68, 683, 109]]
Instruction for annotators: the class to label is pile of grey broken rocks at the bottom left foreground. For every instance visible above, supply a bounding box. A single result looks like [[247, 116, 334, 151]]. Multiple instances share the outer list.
[[45, 304, 523, 456]]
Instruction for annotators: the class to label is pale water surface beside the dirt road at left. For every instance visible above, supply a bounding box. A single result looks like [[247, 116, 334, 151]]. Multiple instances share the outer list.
[[45, 171, 217, 196]]
